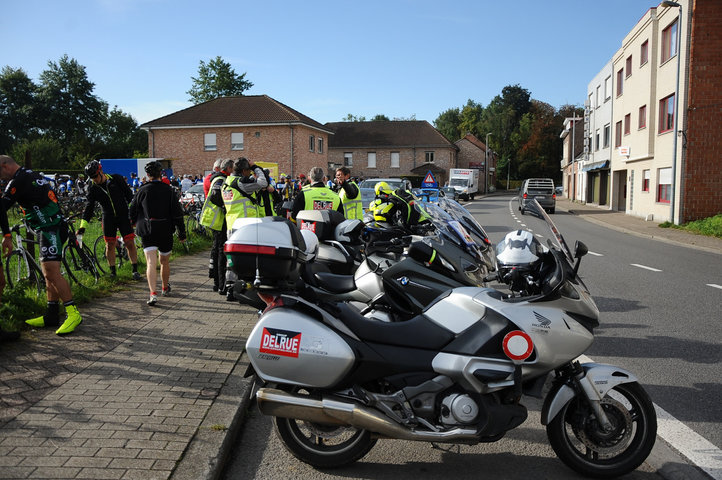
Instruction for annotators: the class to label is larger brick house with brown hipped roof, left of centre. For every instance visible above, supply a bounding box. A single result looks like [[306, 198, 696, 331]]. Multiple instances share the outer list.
[[141, 95, 333, 176]]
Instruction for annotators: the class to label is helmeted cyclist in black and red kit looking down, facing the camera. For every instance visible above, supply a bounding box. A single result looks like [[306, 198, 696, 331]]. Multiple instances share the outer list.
[[77, 160, 141, 280]]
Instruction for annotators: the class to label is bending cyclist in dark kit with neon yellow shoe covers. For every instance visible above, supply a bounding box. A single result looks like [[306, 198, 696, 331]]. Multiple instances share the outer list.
[[0, 155, 83, 335]]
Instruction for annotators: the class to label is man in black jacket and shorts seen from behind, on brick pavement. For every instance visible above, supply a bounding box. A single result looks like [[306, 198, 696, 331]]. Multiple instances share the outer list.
[[129, 161, 186, 305]]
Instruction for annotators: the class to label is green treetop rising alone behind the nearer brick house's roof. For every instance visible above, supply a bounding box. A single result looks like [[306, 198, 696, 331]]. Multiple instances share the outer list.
[[186, 56, 253, 104]]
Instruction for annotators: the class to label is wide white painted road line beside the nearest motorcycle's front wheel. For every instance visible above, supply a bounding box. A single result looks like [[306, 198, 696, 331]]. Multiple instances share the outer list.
[[577, 355, 722, 480]]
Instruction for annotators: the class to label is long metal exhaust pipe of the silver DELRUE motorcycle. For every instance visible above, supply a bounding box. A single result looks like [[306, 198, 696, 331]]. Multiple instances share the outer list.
[[256, 388, 479, 443]]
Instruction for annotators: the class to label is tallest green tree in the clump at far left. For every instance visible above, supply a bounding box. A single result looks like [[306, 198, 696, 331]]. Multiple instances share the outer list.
[[38, 55, 104, 146]]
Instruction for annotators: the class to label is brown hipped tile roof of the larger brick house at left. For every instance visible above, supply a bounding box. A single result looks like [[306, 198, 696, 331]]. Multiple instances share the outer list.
[[141, 95, 328, 131]]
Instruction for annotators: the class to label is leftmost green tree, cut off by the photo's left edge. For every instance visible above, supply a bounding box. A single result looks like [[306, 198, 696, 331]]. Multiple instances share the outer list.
[[0, 66, 38, 152]]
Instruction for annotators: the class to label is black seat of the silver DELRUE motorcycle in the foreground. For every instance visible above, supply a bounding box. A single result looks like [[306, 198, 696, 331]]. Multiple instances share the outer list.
[[336, 303, 454, 350]]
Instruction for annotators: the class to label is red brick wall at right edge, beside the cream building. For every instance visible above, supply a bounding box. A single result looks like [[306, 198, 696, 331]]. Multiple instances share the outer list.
[[680, 0, 722, 223]]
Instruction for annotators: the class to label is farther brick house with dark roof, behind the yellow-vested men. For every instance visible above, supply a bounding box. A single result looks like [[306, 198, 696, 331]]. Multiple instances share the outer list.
[[325, 120, 459, 185]]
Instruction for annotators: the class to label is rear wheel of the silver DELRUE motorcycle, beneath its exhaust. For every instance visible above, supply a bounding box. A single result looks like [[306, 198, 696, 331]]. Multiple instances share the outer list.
[[273, 392, 377, 468]]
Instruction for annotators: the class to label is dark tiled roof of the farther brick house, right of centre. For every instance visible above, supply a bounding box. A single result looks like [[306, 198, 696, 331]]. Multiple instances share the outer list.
[[326, 120, 457, 148]]
